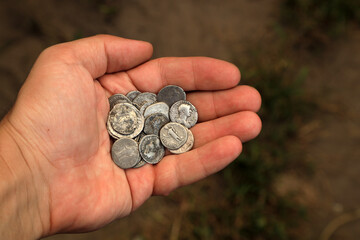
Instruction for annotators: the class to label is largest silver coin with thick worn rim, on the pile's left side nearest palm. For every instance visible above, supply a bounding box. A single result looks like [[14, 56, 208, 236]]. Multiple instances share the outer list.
[[108, 103, 144, 138]]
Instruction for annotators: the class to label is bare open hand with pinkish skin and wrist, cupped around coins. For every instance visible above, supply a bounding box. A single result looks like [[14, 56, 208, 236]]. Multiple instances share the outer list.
[[0, 35, 261, 239]]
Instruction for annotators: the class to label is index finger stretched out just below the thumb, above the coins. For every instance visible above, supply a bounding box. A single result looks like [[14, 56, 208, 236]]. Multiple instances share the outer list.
[[125, 57, 240, 92]]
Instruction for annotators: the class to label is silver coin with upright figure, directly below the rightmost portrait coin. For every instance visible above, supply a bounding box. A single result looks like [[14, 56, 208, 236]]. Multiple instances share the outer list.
[[160, 122, 188, 150]]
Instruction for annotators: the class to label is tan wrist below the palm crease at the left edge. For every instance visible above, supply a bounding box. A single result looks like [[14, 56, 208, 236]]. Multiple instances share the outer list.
[[0, 117, 50, 239]]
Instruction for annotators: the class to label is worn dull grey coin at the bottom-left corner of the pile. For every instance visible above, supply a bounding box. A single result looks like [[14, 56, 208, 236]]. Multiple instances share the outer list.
[[111, 138, 141, 169]]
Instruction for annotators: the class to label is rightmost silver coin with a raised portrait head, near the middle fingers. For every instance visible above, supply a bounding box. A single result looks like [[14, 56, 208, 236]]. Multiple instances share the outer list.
[[170, 101, 198, 128]]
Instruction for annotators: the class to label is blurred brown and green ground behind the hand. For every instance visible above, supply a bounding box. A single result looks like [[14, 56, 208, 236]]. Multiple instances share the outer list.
[[0, 0, 360, 240]]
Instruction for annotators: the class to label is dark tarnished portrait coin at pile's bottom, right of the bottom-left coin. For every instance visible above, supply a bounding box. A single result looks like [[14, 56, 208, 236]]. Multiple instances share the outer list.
[[139, 135, 165, 164]]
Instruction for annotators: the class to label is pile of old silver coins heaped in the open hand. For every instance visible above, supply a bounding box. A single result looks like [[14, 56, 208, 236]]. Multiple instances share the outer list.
[[107, 85, 198, 169]]
